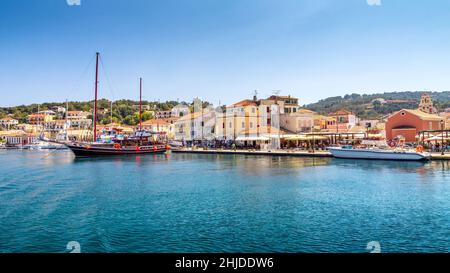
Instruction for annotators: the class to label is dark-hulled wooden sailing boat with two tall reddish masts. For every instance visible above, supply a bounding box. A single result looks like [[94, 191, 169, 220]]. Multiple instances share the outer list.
[[65, 52, 170, 157]]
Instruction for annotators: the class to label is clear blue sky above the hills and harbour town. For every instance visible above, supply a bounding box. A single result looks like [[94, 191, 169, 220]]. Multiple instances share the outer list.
[[0, 0, 450, 106]]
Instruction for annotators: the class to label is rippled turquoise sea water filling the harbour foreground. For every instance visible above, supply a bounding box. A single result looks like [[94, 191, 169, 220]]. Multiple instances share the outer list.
[[0, 150, 450, 252]]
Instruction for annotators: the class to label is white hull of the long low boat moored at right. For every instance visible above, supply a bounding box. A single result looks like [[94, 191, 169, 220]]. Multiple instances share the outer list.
[[328, 147, 431, 161]]
